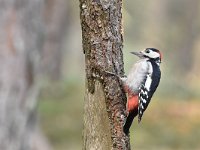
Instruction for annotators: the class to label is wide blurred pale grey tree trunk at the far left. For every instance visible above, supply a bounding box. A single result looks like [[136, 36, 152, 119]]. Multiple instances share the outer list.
[[0, 0, 48, 150]]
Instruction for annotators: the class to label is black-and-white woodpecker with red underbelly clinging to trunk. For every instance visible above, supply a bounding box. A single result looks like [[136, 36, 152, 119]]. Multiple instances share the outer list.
[[108, 48, 162, 134]]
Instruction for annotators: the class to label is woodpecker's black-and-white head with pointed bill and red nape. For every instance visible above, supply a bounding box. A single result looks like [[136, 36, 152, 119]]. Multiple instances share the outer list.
[[131, 48, 162, 63]]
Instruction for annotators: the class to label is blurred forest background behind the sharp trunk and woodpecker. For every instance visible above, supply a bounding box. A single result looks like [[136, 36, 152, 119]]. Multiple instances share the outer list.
[[0, 0, 200, 150]]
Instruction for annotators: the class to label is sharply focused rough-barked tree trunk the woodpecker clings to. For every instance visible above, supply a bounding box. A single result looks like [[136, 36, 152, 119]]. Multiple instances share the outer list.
[[80, 0, 130, 150]]
